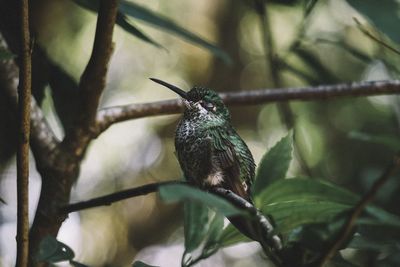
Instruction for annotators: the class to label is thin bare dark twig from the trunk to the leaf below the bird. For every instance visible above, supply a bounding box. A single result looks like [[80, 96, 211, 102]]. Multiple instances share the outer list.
[[60, 181, 186, 213]]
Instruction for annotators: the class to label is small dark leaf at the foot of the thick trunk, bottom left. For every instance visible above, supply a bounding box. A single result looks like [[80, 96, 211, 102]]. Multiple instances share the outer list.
[[36, 236, 75, 263]]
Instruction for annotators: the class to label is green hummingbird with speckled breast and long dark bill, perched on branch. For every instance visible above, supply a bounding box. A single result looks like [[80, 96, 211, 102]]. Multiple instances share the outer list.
[[150, 78, 255, 239]]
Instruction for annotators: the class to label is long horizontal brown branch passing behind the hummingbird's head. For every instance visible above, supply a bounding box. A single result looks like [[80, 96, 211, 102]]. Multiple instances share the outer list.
[[95, 80, 400, 135]]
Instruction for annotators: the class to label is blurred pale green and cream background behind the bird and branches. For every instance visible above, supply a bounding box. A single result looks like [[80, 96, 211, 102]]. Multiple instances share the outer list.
[[0, 0, 400, 267]]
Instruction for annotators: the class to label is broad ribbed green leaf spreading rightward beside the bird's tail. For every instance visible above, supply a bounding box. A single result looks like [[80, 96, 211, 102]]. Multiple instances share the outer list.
[[260, 178, 359, 236]]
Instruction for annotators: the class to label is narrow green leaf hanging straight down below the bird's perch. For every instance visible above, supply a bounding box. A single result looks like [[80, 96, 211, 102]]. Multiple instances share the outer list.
[[184, 201, 209, 253]]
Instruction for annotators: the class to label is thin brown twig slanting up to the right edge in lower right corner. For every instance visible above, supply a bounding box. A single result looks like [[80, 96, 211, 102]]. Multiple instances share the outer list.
[[316, 155, 400, 267]]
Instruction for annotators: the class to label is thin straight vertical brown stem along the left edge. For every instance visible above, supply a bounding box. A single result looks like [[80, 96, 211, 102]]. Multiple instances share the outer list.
[[16, 0, 32, 267]]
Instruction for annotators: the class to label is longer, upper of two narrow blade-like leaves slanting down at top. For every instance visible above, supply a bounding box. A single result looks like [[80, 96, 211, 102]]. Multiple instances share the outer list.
[[120, 1, 232, 64]]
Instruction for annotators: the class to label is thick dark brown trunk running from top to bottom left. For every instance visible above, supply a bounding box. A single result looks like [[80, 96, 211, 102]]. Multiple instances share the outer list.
[[30, 0, 118, 266]]
